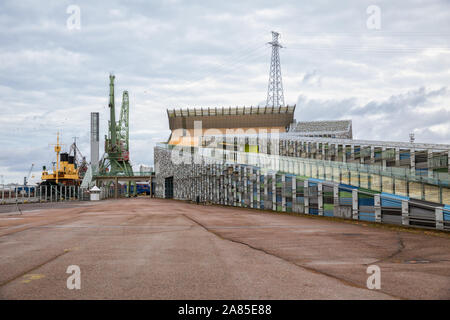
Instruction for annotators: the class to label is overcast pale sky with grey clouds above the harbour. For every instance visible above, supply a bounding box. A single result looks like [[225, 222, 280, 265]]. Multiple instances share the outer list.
[[0, 0, 450, 184]]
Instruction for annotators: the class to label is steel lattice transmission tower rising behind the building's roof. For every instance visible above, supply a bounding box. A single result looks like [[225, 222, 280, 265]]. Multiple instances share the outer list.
[[266, 31, 284, 107]]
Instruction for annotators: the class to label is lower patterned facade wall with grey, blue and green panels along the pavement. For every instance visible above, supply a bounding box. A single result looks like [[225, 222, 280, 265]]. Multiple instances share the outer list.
[[154, 147, 450, 230]]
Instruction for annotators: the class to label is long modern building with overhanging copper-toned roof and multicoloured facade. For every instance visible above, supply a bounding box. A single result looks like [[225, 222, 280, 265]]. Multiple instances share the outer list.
[[154, 106, 450, 230]]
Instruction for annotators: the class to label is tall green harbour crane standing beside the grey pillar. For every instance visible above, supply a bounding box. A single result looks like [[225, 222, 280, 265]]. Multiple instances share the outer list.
[[100, 74, 136, 192]]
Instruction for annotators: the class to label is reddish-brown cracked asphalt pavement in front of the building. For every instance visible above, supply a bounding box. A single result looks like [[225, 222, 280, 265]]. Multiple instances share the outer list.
[[0, 198, 450, 299]]
